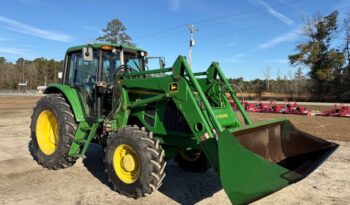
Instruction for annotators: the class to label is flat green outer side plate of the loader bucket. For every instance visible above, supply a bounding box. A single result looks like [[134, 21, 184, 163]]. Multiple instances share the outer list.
[[219, 130, 289, 204]]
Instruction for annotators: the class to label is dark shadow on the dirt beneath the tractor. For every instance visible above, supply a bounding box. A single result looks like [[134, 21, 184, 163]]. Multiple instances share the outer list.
[[83, 144, 222, 204]]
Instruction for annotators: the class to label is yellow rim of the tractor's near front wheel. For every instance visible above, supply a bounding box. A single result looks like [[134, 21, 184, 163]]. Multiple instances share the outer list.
[[113, 144, 140, 184]]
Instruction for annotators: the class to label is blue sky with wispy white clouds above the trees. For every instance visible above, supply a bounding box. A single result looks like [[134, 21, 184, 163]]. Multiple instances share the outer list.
[[0, 0, 350, 79]]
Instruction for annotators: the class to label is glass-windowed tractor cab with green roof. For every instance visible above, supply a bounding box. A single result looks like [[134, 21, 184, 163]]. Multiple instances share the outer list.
[[62, 43, 147, 121]]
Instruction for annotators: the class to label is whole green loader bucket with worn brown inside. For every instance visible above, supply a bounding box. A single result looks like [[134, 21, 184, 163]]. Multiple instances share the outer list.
[[218, 119, 338, 204]]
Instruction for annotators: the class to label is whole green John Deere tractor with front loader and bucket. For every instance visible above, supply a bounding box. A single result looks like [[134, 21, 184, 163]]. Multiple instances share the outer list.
[[31, 43, 338, 204]]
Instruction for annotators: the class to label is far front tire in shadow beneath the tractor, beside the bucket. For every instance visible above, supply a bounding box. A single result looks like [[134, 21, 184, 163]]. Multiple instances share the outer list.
[[174, 150, 210, 172]]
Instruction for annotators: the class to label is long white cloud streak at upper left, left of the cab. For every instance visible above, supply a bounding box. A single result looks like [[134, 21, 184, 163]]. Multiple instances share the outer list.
[[0, 16, 71, 42]]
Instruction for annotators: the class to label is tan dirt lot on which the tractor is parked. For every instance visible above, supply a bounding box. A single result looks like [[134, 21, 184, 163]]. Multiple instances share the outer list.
[[0, 96, 350, 204]]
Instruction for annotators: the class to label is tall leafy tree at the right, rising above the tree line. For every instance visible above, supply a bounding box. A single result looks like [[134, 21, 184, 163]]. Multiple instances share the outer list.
[[289, 11, 344, 100]]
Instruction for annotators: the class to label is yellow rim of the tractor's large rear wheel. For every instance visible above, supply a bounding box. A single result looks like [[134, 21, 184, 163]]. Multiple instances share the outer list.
[[36, 110, 59, 155]]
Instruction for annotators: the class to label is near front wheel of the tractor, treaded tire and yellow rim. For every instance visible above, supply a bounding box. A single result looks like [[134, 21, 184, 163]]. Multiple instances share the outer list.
[[105, 127, 166, 198]]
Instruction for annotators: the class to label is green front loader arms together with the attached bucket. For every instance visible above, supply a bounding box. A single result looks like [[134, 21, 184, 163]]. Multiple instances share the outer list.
[[123, 56, 338, 204]]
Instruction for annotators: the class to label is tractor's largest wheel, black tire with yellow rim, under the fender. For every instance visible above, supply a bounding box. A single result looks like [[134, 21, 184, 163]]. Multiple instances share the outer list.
[[30, 94, 77, 169]]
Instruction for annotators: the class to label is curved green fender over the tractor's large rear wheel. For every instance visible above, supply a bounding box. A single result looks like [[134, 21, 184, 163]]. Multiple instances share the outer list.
[[44, 84, 85, 122]]
